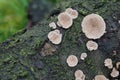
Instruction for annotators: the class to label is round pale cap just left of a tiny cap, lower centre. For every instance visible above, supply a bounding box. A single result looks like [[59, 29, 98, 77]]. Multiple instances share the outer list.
[[67, 55, 78, 67]]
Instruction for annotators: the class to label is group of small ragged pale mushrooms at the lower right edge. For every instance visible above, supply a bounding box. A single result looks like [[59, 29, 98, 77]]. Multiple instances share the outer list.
[[104, 58, 119, 78]]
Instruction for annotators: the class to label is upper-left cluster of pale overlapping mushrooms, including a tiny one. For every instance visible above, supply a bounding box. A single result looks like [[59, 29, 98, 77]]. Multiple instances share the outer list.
[[48, 8, 78, 44]]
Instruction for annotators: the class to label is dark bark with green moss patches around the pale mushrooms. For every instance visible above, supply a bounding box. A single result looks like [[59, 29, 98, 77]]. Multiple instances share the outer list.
[[0, 0, 120, 80]]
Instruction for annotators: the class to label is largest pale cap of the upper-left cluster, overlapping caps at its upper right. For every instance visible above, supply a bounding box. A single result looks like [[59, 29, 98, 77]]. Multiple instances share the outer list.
[[58, 12, 73, 29]]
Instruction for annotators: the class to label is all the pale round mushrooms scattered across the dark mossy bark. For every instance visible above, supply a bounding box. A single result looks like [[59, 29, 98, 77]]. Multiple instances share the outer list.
[[48, 8, 120, 80]]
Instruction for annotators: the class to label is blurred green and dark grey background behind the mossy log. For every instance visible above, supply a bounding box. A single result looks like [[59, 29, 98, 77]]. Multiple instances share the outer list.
[[0, 0, 59, 43]]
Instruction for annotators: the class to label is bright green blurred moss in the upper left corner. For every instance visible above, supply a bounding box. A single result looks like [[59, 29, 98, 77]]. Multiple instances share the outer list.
[[0, 0, 28, 42]]
